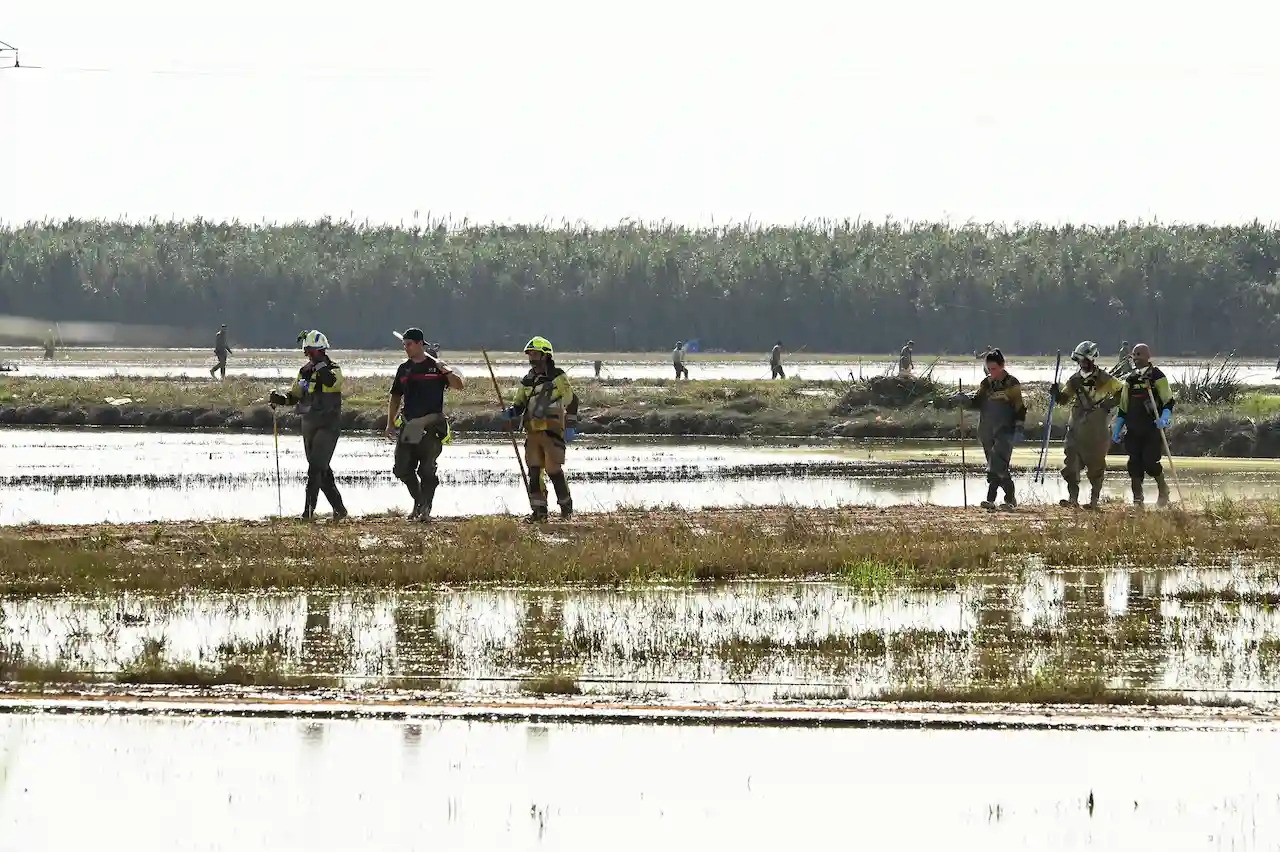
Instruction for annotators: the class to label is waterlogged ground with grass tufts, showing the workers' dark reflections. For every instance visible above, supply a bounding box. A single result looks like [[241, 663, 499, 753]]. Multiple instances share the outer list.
[[15, 564, 1280, 704]]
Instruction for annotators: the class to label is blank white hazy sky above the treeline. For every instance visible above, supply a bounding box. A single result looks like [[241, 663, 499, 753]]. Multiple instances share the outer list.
[[0, 0, 1280, 224]]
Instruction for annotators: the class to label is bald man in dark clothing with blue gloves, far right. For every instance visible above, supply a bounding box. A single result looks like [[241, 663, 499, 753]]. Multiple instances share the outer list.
[[1111, 343, 1174, 509]]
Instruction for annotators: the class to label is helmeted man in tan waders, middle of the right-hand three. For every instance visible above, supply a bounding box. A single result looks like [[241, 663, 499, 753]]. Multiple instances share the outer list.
[[1048, 340, 1124, 509]]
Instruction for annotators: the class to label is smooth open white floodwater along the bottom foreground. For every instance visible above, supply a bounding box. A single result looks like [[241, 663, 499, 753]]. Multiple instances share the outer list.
[[0, 715, 1280, 852]]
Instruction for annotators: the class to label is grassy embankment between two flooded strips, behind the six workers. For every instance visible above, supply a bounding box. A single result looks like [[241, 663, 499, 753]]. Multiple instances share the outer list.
[[0, 376, 1280, 458]]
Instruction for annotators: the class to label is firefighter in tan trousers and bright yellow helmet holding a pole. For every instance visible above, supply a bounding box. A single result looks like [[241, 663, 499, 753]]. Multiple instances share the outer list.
[[502, 338, 576, 522]]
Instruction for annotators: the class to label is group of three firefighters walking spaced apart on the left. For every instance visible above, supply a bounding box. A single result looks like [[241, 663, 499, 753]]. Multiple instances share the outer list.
[[269, 329, 577, 522]]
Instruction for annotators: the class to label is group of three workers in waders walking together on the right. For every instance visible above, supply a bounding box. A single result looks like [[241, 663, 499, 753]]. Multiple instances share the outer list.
[[955, 340, 1174, 509]]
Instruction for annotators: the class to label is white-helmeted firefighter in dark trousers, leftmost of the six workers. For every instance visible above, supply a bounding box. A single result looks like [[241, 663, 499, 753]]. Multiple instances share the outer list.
[[269, 329, 347, 521]]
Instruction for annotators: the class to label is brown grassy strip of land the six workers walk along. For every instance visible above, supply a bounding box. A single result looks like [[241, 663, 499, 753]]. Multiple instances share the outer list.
[[0, 503, 1280, 594]]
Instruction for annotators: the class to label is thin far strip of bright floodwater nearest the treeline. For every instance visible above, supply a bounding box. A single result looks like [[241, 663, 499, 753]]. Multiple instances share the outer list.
[[0, 345, 1280, 385]]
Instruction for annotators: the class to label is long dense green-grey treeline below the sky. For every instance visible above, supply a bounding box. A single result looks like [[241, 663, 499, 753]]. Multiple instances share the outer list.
[[0, 220, 1280, 356]]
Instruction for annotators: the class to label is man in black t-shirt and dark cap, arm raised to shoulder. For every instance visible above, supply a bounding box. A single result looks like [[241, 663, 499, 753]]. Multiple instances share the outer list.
[[387, 329, 462, 522]]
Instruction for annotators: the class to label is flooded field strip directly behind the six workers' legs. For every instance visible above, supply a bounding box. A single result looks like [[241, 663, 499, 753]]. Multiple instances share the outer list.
[[0, 429, 1280, 525]]
